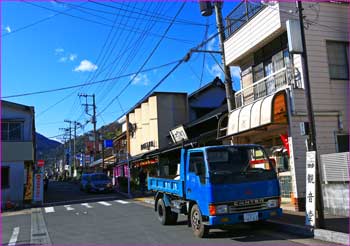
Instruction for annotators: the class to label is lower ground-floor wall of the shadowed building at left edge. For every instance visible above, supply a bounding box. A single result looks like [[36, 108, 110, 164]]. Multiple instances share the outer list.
[[1, 162, 24, 207]]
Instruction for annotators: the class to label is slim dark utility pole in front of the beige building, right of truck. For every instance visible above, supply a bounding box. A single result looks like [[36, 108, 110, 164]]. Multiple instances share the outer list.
[[298, 1, 324, 228]]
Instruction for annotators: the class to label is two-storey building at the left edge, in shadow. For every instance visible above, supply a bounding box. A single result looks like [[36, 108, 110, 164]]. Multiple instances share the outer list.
[[1, 100, 35, 208]]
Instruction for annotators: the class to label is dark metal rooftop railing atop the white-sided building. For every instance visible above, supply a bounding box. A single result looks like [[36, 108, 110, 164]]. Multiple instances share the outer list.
[[225, 0, 266, 39]]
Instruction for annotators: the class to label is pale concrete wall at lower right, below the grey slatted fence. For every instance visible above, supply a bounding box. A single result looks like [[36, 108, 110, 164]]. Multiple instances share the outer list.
[[322, 184, 350, 217]]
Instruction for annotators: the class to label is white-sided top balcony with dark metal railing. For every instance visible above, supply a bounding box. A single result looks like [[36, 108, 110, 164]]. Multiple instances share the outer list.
[[224, 1, 296, 66]]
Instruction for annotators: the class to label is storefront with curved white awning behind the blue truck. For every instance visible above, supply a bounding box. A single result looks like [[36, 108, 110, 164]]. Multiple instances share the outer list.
[[219, 91, 293, 201]]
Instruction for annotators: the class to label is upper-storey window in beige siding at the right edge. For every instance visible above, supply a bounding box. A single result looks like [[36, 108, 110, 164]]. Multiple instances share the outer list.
[[327, 41, 349, 80]]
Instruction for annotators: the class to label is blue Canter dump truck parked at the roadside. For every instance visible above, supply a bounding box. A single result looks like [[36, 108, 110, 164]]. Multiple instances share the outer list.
[[148, 144, 282, 238]]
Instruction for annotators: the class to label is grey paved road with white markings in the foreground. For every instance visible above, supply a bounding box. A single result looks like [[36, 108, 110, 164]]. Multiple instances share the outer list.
[[2, 181, 330, 245]]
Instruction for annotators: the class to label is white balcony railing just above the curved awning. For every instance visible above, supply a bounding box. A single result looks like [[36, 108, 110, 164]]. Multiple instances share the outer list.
[[235, 67, 292, 108]]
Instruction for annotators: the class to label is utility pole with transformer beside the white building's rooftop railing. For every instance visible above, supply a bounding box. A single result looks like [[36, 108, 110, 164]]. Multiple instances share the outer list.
[[199, 0, 236, 112]]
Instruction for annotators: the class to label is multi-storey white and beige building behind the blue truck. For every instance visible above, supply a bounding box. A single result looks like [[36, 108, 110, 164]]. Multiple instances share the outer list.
[[220, 1, 349, 210]]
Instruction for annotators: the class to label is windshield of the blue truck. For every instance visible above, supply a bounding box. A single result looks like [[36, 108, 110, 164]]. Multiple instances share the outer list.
[[207, 146, 276, 184]]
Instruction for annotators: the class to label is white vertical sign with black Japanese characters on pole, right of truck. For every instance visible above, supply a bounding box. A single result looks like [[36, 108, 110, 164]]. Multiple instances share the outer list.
[[305, 151, 316, 226]]
